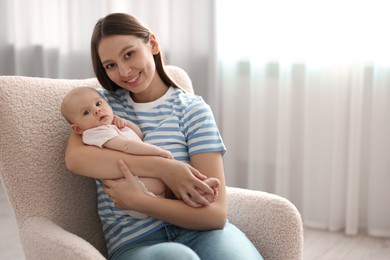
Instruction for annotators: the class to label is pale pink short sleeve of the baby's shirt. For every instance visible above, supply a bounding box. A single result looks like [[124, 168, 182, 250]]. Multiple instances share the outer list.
[[83, 125, 119, 148]]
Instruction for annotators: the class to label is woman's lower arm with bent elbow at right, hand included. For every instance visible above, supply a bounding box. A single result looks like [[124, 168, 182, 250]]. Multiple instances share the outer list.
[[104, 152, 227, 230]]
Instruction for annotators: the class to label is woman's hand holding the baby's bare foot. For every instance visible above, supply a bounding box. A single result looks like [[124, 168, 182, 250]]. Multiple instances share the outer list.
[[161, 160, 214, 207]]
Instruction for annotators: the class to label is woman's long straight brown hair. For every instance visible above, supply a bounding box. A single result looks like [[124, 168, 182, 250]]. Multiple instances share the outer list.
[[91, 13, 179, 91]]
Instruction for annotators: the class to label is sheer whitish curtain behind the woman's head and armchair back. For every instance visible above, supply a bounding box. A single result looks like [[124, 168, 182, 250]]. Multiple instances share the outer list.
[[0, 0, 214, 99]]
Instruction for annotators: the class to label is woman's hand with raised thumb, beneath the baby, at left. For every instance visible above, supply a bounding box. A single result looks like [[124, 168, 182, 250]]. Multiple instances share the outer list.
[[102, 160, 145, 209]]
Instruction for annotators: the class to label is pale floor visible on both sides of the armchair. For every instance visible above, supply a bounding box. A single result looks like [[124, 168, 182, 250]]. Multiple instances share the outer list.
[[0, 184, 390, 260]]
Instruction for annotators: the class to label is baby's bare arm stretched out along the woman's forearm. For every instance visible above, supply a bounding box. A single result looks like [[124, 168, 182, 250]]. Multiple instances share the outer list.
[[103, 135, 173, 159]]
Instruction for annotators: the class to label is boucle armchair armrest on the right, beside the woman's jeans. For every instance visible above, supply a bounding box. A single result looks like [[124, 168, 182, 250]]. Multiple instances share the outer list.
[[227, 187, 303, 260]]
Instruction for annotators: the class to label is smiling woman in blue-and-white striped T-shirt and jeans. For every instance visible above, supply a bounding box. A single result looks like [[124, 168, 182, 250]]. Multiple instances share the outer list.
[[65, 14, 261, 259]]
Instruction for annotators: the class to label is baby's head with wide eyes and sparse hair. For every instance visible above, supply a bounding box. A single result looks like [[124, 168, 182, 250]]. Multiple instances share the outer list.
[[61, 87, 114, 134]]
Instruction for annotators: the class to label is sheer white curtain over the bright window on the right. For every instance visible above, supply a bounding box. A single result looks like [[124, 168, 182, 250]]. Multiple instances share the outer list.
[[216, 0, 390, 237]]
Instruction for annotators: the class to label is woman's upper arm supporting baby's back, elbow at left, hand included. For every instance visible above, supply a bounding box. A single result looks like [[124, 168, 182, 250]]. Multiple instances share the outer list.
[[65, 133, 213, 206]]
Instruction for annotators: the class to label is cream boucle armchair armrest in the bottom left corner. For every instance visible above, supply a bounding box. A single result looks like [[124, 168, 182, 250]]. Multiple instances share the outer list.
[[20, 217, 106, 260]]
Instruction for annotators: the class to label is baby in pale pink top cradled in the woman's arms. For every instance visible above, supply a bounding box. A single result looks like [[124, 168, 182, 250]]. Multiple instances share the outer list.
[[61, 87, 220, 219]]
